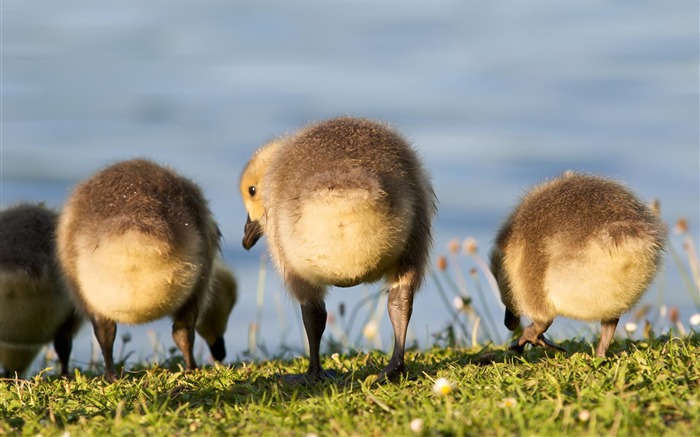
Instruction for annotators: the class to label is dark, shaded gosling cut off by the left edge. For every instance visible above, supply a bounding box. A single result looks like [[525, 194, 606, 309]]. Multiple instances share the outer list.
[[0, 204, 82, 377]]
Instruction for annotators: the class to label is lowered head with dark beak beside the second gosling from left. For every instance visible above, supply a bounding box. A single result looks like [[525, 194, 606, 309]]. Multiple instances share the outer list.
[[196, 256, 238, 361]]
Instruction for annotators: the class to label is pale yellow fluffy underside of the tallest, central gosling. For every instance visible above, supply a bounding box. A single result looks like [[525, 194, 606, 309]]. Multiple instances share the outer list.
[[276, 189, 412, 286]]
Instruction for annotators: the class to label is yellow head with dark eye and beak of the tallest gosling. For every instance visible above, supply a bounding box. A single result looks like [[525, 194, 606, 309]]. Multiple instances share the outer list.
[[240, 140, 282, 250]]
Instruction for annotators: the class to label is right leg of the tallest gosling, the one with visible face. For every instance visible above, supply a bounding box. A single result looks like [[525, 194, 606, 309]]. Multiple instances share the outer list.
[[377, 283, 414, 382]]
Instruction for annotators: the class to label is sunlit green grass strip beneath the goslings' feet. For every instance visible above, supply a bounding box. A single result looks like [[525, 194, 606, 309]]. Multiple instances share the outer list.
[[0, 333, 700, 436]]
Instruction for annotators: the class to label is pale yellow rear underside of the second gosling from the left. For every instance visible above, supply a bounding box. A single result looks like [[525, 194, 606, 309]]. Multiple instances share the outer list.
[[75, 231, 202, 324]]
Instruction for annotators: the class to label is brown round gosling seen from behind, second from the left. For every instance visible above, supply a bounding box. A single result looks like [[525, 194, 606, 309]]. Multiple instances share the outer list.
[[57, 159, 228, 381]]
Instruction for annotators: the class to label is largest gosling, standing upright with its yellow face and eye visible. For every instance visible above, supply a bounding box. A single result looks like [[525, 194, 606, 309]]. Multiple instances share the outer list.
[[240, 117, 436, 383]]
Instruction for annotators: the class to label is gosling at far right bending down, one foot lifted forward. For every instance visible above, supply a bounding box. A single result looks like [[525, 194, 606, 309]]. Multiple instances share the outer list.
[[491, 172, 667, 357]]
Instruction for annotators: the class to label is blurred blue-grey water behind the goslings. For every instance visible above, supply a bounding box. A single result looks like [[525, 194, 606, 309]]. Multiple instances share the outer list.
[[1, 0, 700, 374]]
